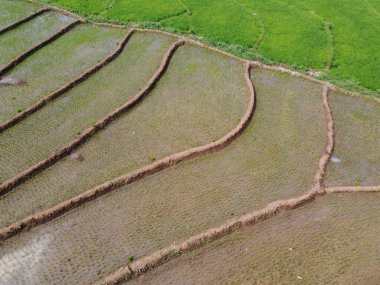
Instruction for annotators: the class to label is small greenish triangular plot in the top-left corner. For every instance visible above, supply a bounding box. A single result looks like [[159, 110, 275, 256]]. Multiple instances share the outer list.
[[0, 0, 41, 30]]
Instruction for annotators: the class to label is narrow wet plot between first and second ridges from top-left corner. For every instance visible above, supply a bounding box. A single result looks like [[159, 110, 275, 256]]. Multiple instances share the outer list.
[[0, 13, 74, 69]]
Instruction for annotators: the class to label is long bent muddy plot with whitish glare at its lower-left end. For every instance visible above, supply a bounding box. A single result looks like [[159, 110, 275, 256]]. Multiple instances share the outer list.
[[3, 67, 326, 284]]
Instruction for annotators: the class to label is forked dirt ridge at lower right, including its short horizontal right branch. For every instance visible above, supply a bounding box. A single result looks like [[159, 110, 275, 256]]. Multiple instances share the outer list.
[[96, 86, 380, 285]]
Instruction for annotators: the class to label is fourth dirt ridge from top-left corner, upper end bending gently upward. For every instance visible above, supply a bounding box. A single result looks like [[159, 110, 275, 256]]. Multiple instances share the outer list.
[[0, 37, 185, 196]]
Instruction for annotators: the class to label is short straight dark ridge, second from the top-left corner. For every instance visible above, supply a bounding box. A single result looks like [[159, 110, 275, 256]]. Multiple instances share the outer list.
[[0, 20, 82, 77]]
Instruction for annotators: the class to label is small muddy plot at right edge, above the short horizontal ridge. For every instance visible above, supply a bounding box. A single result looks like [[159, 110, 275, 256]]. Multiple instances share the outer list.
[[326, 93, 380, 186]]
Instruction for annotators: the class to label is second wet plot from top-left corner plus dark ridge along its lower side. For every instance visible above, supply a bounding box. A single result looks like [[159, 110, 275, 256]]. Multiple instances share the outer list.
[[0, 13, 80, 72]]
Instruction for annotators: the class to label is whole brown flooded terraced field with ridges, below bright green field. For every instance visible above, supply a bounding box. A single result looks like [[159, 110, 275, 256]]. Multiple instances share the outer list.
[[0, 0, 380, 284]]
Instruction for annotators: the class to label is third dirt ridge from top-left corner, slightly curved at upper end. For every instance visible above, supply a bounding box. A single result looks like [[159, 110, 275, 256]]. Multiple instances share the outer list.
[[0, 29, 135, 134]]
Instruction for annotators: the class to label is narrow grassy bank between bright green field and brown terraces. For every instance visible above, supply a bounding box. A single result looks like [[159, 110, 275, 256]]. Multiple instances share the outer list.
[[29, 0, 380, 99]]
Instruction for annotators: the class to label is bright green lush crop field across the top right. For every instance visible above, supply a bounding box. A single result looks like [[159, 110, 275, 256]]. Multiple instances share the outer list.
[[41, 0, 380, 97]]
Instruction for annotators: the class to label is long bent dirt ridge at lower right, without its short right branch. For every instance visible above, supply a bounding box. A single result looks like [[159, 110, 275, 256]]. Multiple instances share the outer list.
[[94, 85, 334, 285]]
